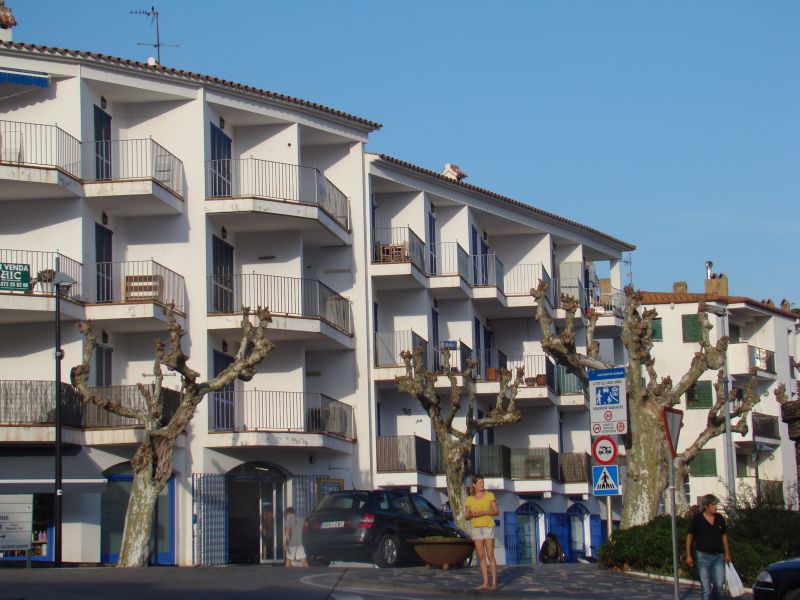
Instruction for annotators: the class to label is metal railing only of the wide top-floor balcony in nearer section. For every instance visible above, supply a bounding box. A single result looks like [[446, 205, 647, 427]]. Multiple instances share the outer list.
[[206, 158, 350, 231]]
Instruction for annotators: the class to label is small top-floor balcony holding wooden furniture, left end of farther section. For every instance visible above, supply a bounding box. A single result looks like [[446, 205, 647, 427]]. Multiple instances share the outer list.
[[370, 227, 427, 290]]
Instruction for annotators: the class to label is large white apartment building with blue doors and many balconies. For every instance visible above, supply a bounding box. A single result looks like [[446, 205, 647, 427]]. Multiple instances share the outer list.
[[0, 18, 634, 565]]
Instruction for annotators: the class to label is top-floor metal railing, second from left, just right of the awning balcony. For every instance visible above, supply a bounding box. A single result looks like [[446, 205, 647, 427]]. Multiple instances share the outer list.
[[81, 138, 183, 197]]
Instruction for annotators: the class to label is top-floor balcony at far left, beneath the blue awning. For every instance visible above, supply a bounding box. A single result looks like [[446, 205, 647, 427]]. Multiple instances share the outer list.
[[0, 121, 81, 201]]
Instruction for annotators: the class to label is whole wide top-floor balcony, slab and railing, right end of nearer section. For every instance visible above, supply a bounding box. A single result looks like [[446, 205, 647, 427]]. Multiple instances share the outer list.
[[206, 158, 351, 245]]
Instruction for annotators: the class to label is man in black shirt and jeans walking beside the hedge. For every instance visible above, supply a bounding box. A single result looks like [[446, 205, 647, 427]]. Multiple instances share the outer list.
[[686, 494, 731, 600]]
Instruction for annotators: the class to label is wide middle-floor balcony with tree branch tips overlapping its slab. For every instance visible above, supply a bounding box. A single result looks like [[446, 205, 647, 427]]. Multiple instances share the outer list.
[[208, 274, 354, 349]]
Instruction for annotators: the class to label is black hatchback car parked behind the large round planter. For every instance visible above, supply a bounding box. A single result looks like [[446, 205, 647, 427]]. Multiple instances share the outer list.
[[303, 490, 468, 567]]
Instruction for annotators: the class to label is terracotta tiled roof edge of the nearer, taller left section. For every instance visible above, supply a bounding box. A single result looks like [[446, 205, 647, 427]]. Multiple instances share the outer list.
[[0, 42, 382, 130]]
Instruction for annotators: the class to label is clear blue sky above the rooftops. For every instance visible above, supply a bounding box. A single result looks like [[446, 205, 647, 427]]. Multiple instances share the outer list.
[[6, 0, 800, 304]]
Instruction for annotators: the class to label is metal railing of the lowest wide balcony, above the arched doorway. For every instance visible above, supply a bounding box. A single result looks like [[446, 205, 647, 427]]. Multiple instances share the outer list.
[[208, 390, 355, 440]]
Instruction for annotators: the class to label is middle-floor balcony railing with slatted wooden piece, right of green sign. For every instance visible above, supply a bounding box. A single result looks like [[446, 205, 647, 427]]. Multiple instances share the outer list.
[[86, 260, 186, 313]]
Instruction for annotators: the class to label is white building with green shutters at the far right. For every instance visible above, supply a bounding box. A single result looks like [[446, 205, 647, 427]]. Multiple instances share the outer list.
[[642, 276, 800, 506]]
